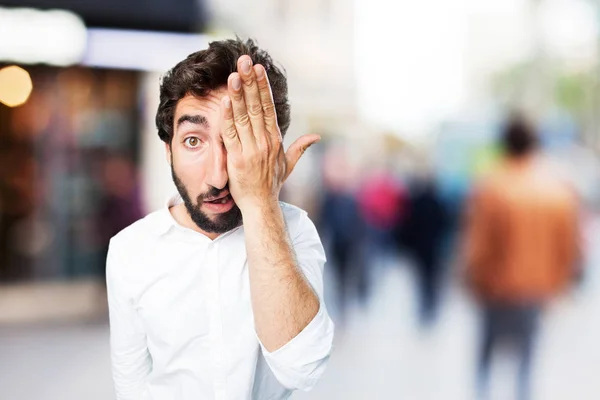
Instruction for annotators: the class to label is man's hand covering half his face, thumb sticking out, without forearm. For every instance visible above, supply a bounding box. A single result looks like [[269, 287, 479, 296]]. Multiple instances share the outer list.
[[221, 55, 321, 212]]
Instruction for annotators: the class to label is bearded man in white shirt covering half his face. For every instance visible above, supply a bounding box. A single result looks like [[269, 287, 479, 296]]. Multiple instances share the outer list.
[[107, 39, 334, 400]]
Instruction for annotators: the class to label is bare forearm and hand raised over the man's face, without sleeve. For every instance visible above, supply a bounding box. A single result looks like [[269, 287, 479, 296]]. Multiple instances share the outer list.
[[221, 56, 320, 351]]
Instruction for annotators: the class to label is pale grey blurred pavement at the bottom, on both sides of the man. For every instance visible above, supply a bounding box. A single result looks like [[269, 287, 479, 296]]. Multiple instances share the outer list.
[[0, 220, 600, 400]]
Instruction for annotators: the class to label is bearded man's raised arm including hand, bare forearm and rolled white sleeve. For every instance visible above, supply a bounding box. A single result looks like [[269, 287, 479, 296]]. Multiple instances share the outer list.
[[221, 56, 333, 390]]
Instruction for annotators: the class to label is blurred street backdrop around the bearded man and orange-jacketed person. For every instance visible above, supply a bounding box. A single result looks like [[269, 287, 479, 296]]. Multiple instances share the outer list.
[[0, 0, 600, 400]]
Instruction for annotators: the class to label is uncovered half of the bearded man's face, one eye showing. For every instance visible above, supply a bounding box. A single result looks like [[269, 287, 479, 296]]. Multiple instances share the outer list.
[[167, 88, 242, 233]]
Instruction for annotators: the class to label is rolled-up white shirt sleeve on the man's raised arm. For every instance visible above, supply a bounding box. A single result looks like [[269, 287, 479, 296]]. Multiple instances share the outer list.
[[259, 213, 334, 391]]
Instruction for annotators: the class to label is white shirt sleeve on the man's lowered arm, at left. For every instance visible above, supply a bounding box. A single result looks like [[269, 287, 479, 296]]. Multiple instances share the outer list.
[[106, 239, 152, 400]]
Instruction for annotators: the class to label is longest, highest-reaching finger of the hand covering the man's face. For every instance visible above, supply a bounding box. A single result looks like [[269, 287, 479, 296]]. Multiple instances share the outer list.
[[238, 55, 267, 146]]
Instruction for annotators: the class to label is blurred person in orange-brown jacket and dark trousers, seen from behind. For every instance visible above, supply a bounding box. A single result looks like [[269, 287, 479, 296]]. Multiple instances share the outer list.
[[466, 116, 579, 399]]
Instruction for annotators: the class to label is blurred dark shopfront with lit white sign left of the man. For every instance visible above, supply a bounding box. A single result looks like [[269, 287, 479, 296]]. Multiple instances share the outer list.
[[0, 0, 209, 283]]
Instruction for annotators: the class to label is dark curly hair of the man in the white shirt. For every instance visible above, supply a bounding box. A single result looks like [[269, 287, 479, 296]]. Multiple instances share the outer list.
[[156, 38, 290, 145]]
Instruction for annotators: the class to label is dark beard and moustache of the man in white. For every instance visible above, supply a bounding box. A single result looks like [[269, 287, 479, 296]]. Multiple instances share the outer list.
[[171, 164, 242, 233]]
